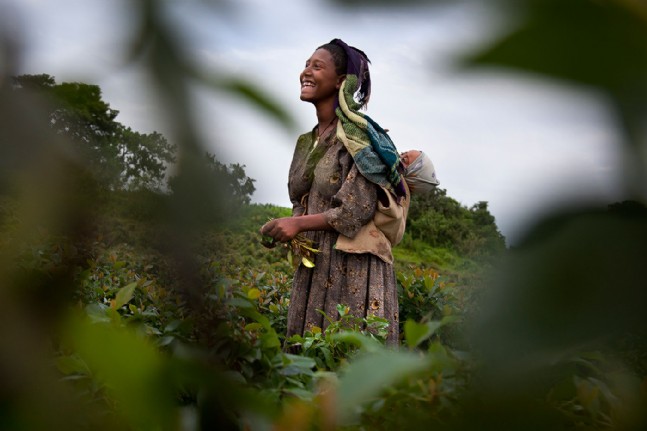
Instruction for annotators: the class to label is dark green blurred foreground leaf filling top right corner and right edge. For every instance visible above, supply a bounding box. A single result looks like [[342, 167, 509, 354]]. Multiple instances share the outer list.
[[465, 0, 647, 199]]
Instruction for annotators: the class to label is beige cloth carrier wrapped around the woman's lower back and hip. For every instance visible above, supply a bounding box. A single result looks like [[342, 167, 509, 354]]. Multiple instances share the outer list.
[[335, 183, 411, 264]]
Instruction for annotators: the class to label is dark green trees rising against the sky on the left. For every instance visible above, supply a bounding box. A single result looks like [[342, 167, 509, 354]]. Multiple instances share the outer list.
[[13, 74, 175, 190]]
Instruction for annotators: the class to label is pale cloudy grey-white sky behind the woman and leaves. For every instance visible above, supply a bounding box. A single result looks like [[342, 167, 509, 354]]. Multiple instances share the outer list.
[[0, 0, 621, 244]]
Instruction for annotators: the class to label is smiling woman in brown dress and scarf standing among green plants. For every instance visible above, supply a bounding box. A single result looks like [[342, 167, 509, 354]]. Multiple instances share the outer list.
[[261, 39, 405, 345]]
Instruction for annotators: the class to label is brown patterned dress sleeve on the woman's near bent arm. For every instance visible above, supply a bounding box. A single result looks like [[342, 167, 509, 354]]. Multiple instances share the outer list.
[[324, 161, 377, 238]]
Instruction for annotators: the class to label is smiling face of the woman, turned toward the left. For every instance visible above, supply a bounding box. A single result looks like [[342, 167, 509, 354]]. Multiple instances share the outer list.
[[299, 48, 344, 103]]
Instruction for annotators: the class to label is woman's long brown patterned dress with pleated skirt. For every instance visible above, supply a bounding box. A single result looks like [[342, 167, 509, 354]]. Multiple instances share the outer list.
[[287, 126, 399, 346]]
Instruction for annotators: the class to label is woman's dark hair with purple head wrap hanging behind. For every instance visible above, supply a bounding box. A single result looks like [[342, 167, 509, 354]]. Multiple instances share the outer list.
[[317, 39, 371, 107]]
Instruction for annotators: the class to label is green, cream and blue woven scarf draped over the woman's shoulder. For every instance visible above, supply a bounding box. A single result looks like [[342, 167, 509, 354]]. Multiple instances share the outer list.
[[335, 75, 406, 197]]
